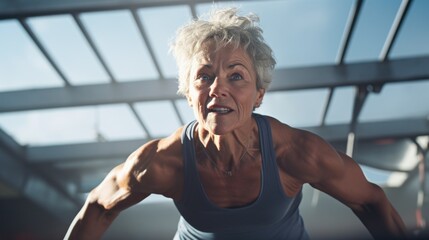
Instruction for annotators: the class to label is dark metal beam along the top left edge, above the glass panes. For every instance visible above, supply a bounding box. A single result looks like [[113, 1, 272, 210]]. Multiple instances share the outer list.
[[0, 0, 234, 20]]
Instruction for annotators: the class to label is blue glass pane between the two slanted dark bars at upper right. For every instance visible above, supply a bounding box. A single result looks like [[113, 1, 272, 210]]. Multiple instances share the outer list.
[[345, 0, 401, 62]]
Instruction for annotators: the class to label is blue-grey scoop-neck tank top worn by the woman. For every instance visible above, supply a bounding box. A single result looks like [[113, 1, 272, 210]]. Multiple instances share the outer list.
[[174, 113, 308, 240]]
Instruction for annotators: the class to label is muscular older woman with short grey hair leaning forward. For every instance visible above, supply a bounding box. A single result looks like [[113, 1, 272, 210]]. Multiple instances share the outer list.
[[66, 8, 405, 240]]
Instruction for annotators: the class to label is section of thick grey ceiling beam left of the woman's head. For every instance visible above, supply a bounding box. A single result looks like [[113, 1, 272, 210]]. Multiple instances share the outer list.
[[0, 79, 179, 112]]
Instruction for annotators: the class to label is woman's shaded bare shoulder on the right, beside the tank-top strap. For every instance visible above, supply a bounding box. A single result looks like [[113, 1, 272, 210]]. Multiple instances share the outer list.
[[268, 114, 343, 183]]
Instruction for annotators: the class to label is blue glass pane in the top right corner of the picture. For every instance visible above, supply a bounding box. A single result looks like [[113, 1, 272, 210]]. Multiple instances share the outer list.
[[389, 0, 429, 58]]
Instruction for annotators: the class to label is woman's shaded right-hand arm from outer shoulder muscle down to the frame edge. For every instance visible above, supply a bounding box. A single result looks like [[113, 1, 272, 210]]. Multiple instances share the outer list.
[[311, 140, 406, 239]]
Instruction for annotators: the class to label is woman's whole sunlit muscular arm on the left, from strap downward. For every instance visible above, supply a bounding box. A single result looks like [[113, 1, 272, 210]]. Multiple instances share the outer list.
[[65, 129, 182, 239]]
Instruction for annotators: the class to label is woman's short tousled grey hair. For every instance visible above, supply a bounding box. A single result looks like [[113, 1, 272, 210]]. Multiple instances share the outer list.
[[170, 8, 276, 96]]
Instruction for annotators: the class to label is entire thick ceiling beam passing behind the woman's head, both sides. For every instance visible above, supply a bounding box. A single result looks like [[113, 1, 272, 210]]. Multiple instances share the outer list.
[[0, 56, 429, 113]]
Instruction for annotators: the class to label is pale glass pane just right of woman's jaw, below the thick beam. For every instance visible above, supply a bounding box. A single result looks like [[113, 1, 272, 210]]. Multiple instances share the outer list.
[[256, 89, 328, 127]]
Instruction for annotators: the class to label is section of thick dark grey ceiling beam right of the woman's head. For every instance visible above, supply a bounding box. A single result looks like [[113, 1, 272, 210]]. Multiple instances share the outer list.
[[270, 56, 429, 91]]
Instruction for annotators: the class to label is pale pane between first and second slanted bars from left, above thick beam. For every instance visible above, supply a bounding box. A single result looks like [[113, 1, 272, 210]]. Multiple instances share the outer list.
[[28, 15, 109, 85]]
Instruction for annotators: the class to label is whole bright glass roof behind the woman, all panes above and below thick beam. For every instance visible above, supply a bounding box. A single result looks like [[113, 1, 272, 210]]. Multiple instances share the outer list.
[[0, 0, 429, 188]]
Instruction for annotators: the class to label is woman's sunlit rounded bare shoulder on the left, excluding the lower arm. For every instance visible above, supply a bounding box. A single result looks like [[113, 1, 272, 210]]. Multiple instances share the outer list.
[[118, 127, 183, 197]]
